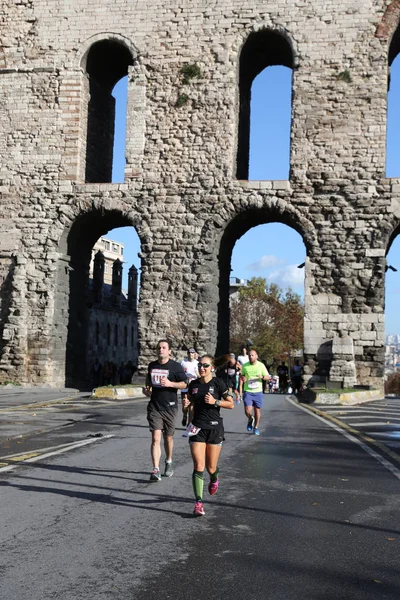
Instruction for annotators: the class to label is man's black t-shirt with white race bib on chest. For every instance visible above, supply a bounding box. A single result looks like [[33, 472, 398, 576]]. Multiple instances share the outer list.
[[147, 360, 186, 410]]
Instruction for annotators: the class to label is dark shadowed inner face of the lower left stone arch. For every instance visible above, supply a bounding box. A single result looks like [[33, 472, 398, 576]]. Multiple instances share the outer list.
[[52, 206, 146, 388]]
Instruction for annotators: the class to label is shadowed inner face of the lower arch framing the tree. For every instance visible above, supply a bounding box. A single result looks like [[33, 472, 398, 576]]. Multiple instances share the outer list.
[[217, 206, 314, 355]]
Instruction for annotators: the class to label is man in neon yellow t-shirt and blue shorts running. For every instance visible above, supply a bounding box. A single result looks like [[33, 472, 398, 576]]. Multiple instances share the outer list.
[[242, 348, 270, 435]]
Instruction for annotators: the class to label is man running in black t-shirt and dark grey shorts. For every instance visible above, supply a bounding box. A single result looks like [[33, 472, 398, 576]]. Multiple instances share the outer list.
[[143, 340, 186, 481]]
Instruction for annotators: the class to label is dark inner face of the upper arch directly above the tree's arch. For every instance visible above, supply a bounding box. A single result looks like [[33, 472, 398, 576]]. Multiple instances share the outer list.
[[236, 27, 295, 180]]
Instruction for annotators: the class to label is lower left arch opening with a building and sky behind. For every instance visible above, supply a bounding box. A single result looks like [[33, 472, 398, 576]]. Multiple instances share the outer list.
[[53, 210, 140, 389]]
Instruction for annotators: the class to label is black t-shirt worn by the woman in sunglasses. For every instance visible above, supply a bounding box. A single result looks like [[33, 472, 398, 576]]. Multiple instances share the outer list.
[[188, 377, 229, 429]]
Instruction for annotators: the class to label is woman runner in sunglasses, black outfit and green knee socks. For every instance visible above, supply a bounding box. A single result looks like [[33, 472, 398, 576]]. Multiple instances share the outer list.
[[184, 354, 234, 516]]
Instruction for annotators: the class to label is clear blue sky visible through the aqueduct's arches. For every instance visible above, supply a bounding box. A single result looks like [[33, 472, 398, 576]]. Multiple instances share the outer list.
[[107, 65, 400, 333]]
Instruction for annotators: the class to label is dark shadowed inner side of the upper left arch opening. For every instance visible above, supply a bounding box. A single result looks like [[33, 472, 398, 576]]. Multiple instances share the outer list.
[[85, 39, 133, 183]]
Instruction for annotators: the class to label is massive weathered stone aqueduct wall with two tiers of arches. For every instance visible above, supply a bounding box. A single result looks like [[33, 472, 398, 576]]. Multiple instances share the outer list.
[[0, 0, 400, 385]]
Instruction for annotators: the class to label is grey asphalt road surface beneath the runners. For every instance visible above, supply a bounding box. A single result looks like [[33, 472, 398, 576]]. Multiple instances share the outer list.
[[0, 395, 400, 600]]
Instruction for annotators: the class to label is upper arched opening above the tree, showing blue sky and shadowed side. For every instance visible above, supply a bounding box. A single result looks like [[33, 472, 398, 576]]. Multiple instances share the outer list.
[[236, 29, 293, 180]]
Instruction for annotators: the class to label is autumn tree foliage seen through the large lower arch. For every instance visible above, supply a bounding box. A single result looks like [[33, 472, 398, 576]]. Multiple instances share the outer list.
[[230, 277, 304, 365]]
